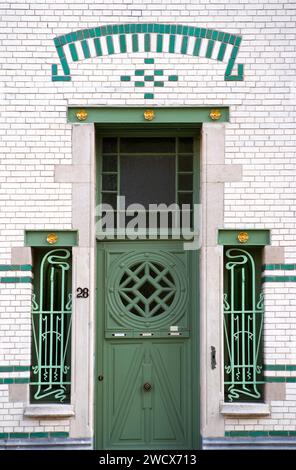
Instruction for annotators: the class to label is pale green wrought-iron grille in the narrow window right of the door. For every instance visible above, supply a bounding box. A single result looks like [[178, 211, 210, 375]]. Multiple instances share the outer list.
[[224, 248, 263, 401]]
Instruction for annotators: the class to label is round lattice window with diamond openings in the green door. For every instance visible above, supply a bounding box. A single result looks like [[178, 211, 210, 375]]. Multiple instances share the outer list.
[[108, 253, 187, 327]]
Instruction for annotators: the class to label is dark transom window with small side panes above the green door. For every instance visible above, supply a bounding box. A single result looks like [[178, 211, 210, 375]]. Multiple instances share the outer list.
[[100, 137, 194, 209]]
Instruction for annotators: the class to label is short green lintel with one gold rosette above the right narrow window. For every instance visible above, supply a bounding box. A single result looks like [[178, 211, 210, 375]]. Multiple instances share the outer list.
[[218, 228, 270, 247]]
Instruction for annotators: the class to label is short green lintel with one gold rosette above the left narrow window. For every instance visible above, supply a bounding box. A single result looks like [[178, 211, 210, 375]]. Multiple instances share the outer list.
[[25, 229, 78, 248]]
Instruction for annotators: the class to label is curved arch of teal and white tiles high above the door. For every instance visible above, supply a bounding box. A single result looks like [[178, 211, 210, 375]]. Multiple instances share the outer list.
[[52, 23, 243, 81]]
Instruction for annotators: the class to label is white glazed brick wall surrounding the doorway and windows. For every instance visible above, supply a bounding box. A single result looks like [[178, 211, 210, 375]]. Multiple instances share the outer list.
[[0, 0, 296, 432]]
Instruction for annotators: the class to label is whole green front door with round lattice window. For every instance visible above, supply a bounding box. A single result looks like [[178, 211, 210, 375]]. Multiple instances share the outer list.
[[96, 241, 199, 450]]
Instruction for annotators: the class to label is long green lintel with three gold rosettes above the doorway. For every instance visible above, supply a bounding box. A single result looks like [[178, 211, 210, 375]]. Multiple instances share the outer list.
[[68, 107, 229, 124]]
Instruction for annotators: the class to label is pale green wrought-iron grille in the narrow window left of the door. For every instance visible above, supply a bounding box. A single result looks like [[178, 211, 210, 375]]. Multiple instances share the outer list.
[[31, 248, 72, 403]]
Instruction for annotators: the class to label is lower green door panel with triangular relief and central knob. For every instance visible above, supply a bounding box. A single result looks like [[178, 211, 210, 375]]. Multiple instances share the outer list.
[[104, 340, 191, 448]]
